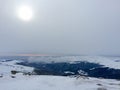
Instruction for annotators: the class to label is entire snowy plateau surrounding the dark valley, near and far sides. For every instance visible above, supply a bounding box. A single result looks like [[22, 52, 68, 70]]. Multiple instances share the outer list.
[[0, 56, 120, 90]]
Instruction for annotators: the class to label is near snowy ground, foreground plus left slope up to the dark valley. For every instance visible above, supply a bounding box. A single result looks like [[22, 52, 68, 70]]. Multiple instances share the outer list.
[[0, 57, 120, 90]]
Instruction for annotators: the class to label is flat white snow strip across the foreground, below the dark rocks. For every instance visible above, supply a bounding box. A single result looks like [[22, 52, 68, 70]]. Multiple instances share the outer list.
[[0, 75, 120, 90]]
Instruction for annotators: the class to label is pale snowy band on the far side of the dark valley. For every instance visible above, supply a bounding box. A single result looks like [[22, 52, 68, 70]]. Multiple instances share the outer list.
[[28, 56, 120, 69]]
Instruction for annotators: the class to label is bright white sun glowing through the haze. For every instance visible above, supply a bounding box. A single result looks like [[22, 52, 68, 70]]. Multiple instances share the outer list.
[[17, 5, 33, 21]]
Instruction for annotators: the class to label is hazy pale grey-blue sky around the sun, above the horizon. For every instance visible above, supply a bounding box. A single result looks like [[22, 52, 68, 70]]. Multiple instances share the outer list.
[[0, 0, 120, 55]]
